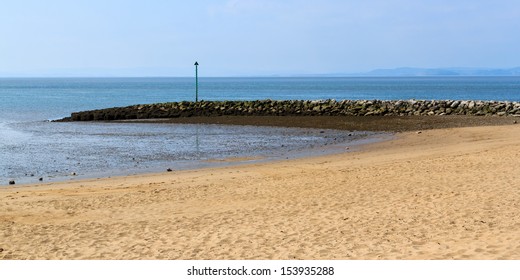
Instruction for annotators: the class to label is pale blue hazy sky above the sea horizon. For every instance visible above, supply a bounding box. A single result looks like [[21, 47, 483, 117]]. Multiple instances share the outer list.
[[0, 0, 520, 77]]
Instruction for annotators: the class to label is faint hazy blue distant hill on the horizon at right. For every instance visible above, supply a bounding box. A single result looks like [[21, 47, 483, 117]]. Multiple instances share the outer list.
[[354, 67, 520, 77]]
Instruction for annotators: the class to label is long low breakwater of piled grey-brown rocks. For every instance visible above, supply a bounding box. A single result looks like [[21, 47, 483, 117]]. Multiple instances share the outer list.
[[60, 100, 520, 121]]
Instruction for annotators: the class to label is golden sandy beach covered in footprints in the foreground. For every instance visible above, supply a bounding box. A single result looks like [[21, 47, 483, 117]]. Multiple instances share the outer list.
[[0, 118, 520, 259]]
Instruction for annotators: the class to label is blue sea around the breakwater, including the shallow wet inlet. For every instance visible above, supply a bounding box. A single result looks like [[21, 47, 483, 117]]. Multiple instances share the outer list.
[[0, 77, 520, 185]]
